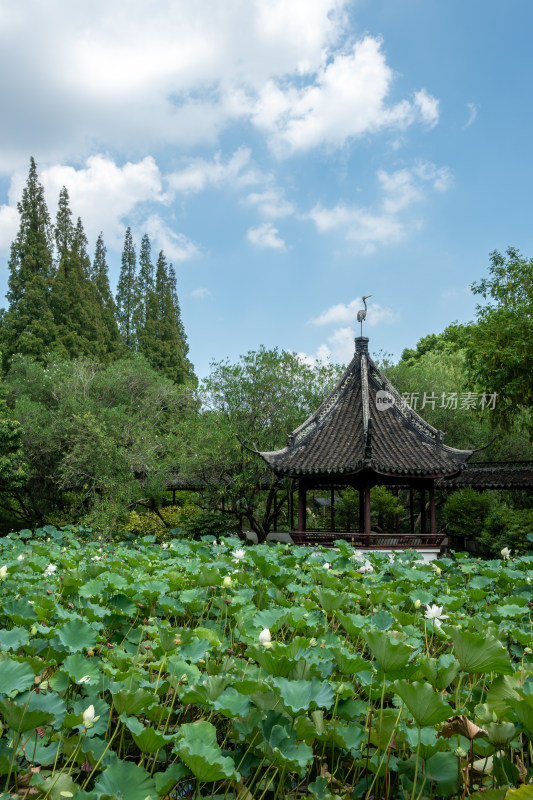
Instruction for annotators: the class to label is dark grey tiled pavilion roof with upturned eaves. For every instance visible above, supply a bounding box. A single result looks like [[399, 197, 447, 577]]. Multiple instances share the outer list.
[[260, 337, 472, 477]]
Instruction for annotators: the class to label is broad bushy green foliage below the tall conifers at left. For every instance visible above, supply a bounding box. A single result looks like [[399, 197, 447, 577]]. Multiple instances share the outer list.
[[6, 356, 195, 529]]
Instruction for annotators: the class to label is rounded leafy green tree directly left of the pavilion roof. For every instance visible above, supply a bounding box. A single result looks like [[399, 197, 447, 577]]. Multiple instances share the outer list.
[[175, 348, 341, 541]]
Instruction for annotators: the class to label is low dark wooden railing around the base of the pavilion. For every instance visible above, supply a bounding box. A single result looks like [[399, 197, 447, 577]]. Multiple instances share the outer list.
[[290, 530, 446, 550]]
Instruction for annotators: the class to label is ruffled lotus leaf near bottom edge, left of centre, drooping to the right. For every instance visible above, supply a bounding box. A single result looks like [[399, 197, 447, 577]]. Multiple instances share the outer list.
[[174, 721, 240, 780]]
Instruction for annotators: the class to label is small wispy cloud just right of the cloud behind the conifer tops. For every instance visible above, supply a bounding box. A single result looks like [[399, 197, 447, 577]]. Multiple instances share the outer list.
[[168, 147, 259, 194]]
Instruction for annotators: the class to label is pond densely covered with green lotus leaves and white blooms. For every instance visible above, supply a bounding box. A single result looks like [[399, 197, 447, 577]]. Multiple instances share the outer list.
[[0, 527, 533, 800]]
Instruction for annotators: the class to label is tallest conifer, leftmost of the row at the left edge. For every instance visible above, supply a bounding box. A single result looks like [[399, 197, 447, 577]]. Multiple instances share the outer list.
[[1, 158, 56, 368]]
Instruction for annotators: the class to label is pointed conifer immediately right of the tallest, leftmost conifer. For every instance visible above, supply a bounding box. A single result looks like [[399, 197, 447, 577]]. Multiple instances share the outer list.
[[51, 187, 107, 361]]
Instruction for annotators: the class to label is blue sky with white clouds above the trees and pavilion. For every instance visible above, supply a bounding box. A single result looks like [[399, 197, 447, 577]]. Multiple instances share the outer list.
[[0, 0, 533, 377]]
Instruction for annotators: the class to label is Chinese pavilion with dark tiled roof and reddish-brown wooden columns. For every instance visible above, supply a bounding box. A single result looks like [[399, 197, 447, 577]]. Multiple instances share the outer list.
[[254, 336, 475, 547]]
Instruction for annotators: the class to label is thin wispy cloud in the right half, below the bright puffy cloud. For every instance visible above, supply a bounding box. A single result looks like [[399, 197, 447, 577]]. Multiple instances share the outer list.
[[307, 163, 452, 253]]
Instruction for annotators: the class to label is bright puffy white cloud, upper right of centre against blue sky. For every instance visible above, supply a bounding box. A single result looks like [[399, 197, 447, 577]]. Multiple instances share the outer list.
[[254, 36, 438, 153]]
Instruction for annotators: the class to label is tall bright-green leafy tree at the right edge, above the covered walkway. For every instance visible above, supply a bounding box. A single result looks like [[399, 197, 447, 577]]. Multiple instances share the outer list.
[[466, 247, 533, 439]]
